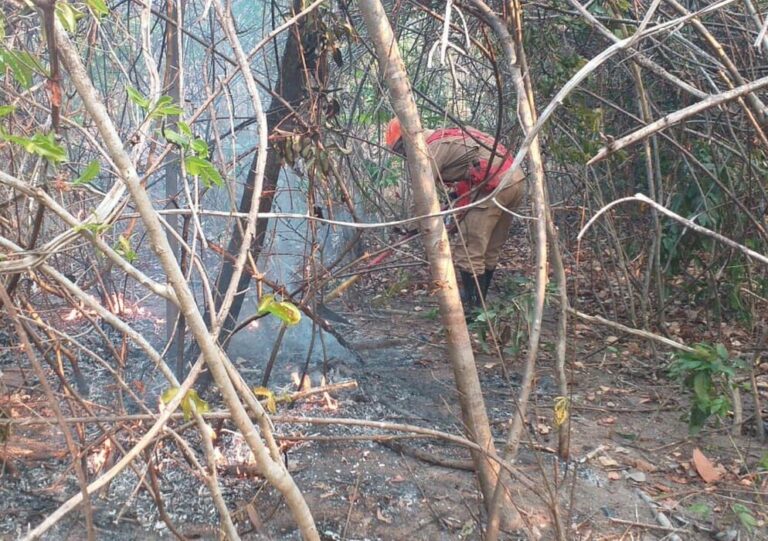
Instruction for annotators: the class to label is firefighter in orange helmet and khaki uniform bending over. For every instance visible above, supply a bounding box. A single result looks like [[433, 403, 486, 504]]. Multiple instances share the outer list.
[[386, 117, 525, 311]]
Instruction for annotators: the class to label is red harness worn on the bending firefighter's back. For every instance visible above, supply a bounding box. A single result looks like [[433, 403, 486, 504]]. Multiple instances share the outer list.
[[427, 128, 514, 207]]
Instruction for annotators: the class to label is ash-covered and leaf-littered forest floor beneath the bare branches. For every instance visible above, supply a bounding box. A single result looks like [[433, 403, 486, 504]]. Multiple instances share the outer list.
[[0, 230, 768, 541]]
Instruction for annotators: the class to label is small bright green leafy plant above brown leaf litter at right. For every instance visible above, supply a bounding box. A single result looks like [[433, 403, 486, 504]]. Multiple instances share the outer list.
[[669, 344, 741, 435]]
